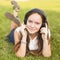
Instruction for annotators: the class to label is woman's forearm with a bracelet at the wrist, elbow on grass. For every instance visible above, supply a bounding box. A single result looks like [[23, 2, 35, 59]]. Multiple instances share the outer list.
[[16, 37, 26, 57]]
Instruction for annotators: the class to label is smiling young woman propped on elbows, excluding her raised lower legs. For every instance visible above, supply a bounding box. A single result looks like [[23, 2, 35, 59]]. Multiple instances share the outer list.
[[8, 8, 51, 57]]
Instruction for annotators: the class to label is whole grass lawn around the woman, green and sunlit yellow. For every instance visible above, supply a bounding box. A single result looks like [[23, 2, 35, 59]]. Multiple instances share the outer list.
[[0, 0, 60, 60]]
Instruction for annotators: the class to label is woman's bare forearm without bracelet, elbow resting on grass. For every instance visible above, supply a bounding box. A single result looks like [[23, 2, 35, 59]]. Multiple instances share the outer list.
[[42, 39, 51, 57]]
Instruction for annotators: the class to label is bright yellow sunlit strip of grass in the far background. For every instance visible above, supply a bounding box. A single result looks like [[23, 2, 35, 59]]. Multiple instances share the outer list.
[[0, 0, 60, 12]]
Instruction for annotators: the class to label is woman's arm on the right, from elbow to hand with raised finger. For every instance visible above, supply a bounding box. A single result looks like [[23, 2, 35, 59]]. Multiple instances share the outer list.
[[41, 25, 51, 57]]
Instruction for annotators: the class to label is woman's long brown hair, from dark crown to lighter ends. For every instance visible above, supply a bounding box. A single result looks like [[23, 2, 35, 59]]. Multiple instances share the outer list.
[[14, 8, 49, 55]]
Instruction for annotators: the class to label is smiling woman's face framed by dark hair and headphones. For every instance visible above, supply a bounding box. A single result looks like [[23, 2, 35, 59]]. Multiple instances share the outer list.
[[26, 13, 42, 34]]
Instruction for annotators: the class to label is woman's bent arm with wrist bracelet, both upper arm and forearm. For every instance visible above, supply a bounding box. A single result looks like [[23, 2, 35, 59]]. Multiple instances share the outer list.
[[14, 30, 27, 57]]
